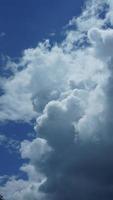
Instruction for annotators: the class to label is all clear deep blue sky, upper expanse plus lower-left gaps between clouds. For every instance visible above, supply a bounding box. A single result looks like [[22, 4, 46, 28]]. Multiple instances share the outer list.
[[0, 0, 84, 180]]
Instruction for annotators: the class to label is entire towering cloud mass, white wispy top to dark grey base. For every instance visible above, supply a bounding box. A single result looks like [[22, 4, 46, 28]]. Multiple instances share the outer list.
[[0, 0, 113, 200]]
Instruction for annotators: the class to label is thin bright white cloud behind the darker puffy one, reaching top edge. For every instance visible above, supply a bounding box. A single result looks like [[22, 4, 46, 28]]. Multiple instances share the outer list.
[[0, 1, 109, 121]]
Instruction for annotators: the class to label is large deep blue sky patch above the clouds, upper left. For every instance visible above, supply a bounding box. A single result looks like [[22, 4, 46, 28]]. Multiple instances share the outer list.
[[0, 0, 84, 57]]
